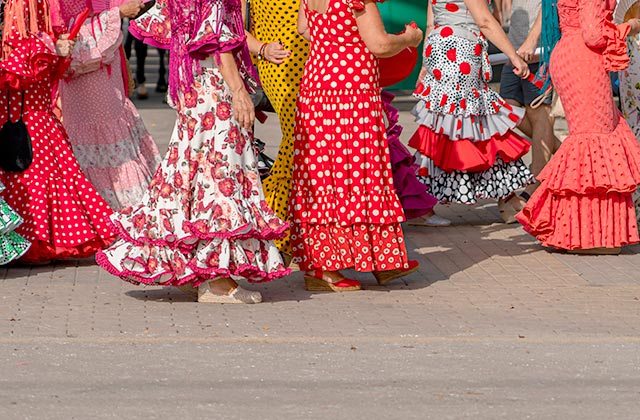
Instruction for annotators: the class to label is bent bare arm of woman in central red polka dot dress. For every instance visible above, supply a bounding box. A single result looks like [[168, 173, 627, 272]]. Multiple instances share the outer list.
[[355, 0, 422, 58]]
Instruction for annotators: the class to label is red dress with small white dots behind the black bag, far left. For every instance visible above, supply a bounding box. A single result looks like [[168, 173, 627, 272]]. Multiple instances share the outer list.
[[0, 43, 113, 261]]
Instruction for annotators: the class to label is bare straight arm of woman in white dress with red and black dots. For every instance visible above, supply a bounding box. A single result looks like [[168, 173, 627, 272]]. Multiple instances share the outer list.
[[464, 0, 529, 77]]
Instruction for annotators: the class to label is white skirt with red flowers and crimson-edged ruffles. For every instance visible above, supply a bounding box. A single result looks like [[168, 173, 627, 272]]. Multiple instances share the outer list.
[[96, 68, 290, 286]]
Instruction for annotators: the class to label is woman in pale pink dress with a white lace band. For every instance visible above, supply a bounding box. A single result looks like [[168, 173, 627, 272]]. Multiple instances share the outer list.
[[60, 0, 160, 210]]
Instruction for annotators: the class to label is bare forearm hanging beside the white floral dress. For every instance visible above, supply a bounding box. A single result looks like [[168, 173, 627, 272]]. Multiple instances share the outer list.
[[218, 52, 256, 130]]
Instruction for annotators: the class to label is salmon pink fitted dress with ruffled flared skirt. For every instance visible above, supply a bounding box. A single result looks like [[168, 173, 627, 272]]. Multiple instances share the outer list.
[[517, 0, 640, 250]]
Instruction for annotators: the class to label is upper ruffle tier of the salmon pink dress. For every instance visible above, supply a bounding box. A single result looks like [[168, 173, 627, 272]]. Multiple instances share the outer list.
[[538, 116, 640, 195]]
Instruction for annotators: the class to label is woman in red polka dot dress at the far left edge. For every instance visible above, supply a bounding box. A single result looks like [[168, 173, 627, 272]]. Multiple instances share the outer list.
[[0, 0, 113, 263]]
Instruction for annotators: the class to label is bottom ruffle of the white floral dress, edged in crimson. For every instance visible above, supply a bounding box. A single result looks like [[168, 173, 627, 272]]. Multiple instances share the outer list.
[[96, 236, 291, 287]]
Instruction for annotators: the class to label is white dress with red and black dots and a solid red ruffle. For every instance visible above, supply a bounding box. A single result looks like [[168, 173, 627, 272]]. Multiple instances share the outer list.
[[409, 0, 532, 204]]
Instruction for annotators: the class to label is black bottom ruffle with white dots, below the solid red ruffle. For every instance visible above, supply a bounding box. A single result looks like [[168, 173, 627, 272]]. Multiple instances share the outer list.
[[418, 155, 533, 204]]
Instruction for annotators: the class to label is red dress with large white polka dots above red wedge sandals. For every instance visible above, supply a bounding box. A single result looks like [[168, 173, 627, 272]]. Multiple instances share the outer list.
[[291, 0, 408, 272]]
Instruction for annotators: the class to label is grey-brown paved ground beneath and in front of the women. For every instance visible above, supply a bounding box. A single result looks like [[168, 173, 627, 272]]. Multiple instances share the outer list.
[[0, 97, 640, 419]]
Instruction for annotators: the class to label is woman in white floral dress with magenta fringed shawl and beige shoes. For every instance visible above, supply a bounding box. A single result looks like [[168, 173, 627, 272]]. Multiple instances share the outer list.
[[97, 0, 289, 303]]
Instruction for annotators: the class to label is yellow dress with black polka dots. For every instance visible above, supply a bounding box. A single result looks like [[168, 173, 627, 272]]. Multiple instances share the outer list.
[[250, 0, 309, 254]]
